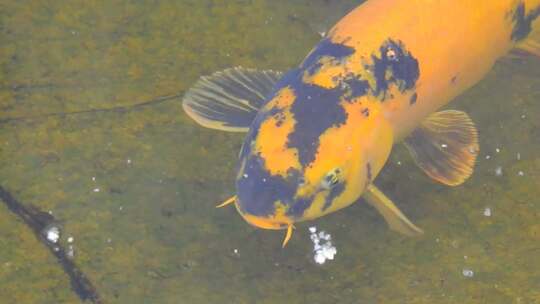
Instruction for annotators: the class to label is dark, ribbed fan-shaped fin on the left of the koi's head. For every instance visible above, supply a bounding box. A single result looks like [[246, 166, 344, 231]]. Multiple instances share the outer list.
[[182, 67, 282, 132]]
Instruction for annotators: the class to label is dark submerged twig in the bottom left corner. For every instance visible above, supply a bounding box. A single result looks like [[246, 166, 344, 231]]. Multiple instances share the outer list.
[[0, 186, 103, 304]]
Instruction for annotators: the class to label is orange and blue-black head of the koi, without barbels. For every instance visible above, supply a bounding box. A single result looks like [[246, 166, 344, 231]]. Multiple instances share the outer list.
[[232, 83, 393, 229]]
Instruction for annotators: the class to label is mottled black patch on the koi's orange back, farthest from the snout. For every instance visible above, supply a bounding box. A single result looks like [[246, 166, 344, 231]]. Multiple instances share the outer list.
[[368, 39, 420, 101]]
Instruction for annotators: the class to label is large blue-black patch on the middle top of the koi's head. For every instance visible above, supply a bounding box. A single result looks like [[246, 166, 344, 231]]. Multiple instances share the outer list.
[[287, 81, 347, 167]]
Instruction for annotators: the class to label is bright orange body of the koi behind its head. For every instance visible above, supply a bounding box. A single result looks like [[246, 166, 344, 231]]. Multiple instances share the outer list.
[[329, 0, 540, 141]]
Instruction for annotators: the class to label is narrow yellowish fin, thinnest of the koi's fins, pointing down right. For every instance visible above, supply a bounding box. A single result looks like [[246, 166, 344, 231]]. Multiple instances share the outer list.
[[363, 184, 424, 236]]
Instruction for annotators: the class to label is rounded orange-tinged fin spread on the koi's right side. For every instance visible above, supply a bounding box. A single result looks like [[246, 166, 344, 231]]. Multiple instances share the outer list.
[[405, 110, 479, 186]]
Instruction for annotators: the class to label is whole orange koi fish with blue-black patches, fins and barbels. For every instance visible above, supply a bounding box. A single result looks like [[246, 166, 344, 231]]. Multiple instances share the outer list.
[[183, 0, 540, 246]]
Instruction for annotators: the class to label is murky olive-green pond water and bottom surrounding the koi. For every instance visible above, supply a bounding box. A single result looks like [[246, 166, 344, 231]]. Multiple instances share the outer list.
[[0, 0, 540, 303]]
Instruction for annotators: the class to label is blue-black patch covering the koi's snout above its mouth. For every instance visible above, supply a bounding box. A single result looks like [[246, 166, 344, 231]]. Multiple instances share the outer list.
[[236, 155, 301, 216]]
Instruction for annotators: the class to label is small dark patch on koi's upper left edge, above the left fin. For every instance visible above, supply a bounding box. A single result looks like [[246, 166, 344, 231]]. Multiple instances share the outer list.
[[300, 38, 355, 74]]
